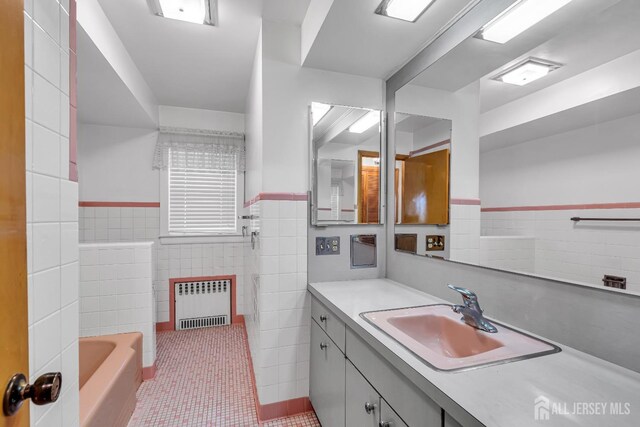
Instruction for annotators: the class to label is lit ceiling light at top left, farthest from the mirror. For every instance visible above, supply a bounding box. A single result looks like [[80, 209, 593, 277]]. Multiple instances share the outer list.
[[147, 0, 218, 25]]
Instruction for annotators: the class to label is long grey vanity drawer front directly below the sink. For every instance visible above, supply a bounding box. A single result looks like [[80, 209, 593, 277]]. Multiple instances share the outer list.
[[346, 329, 442, 427]]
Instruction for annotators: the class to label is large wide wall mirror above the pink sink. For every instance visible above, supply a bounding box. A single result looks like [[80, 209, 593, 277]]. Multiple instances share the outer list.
[[390, 0, 640, 293]]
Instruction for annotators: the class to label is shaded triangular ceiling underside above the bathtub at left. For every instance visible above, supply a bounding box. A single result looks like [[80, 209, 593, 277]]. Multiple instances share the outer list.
[[77, 25, 156, 128]]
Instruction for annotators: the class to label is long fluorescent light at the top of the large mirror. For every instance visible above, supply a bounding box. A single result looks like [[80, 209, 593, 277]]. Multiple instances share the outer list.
[[478, 0, 571, 43]]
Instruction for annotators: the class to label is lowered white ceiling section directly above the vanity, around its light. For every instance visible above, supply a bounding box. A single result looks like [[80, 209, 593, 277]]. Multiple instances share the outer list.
[[302, 0, 478, 78]]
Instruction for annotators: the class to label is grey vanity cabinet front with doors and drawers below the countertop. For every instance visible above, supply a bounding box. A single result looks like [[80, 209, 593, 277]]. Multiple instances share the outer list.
[[309, 298, 460, 427]]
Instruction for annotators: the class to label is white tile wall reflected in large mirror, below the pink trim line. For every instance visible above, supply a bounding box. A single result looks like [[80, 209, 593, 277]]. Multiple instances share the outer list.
[[482, 209, 640, 292]]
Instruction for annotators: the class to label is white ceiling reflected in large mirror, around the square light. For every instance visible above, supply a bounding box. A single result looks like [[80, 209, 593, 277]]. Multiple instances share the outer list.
[[411, 0, 640, 112]]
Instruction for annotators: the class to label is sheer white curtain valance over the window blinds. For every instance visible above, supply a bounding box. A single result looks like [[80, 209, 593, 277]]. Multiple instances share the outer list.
[[153, 128, 245, 172]]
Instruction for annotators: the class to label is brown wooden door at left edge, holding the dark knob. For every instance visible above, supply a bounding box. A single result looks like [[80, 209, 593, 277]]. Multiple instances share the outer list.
[[0, 0, 29, 427]]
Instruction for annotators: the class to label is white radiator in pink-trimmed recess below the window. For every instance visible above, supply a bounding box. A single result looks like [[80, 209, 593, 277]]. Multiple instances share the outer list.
[[175, 279, 231, 331]]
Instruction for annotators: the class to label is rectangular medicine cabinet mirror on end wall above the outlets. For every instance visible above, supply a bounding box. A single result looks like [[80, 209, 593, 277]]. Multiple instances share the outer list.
[[310, 102, 384, 226]]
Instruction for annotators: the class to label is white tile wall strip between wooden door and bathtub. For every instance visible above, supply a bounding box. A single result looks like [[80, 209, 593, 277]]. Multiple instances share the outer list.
[[24, 0, 79, 427]]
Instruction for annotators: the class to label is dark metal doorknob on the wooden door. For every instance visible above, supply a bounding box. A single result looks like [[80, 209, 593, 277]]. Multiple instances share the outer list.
[[2, 372, 62, 417]]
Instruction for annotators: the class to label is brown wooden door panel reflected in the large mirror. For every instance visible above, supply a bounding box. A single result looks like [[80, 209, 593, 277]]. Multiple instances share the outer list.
[[401, 149, 449, 224]]
